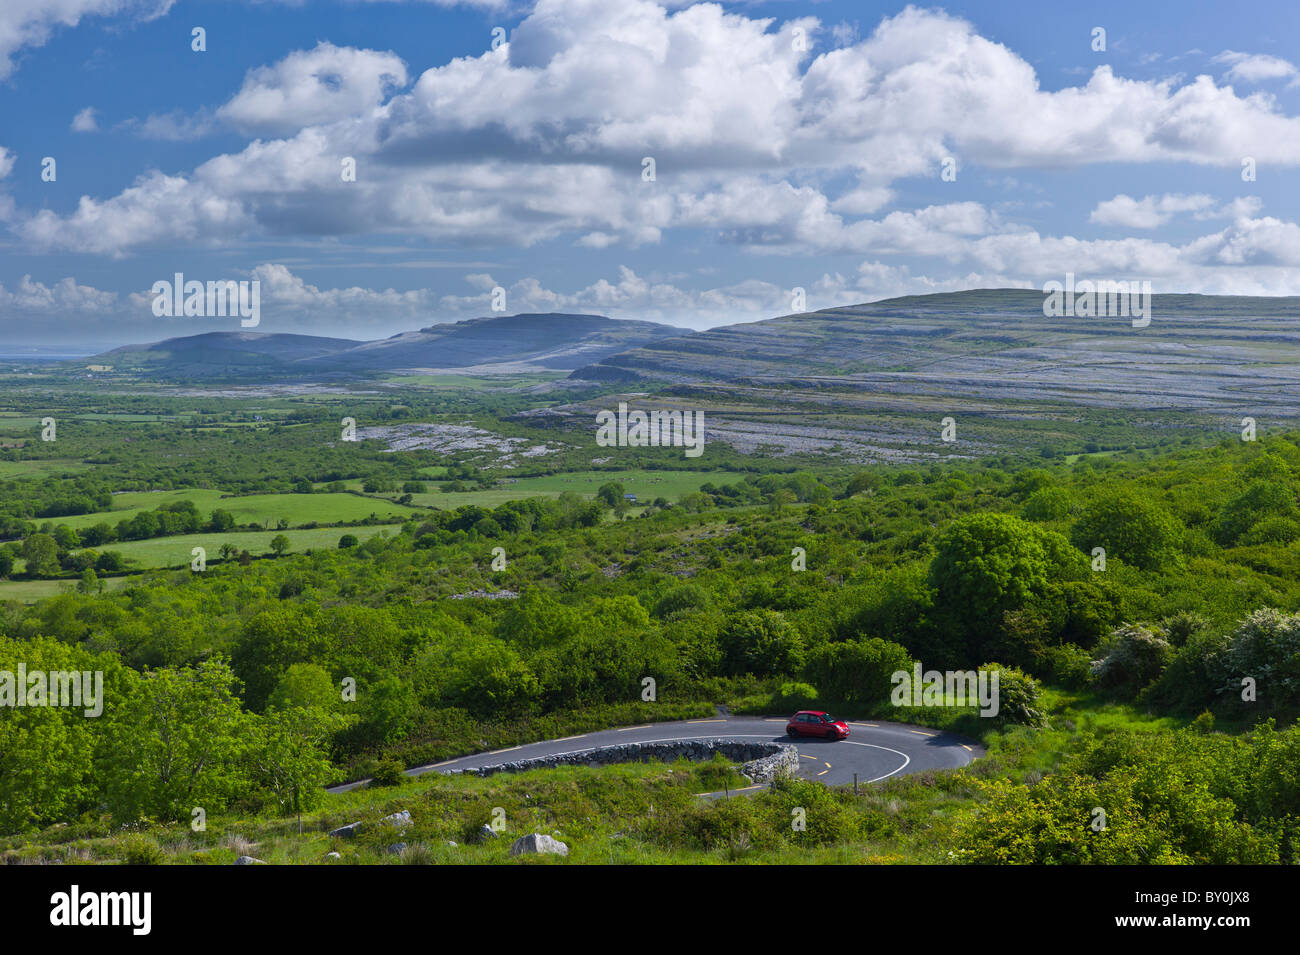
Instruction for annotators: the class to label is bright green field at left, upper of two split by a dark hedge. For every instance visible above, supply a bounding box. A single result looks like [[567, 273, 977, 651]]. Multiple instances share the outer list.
[[49, 487, 416, 530]]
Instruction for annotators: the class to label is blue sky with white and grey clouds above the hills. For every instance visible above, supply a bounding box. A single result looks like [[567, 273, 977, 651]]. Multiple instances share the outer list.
[[0, 0, 1300, 351]]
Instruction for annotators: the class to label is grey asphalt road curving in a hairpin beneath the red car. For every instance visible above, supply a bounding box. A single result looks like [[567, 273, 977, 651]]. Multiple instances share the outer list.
[[328, 716, 984, 793]]
